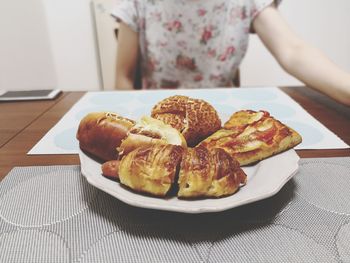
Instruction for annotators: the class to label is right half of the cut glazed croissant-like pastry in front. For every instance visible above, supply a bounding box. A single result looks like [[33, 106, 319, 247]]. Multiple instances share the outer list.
[[178, 146, 247, 198]]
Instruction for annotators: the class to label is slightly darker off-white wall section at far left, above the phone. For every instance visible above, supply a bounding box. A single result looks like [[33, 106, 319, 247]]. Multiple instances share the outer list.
[[0, 0, 57, 90]]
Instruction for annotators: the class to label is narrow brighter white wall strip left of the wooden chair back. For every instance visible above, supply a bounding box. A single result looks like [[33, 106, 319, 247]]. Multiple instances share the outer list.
[[42, 0, 101, 90]]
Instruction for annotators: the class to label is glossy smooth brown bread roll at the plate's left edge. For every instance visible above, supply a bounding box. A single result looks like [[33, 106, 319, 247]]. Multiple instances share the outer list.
[[76, 112, 135, 161]]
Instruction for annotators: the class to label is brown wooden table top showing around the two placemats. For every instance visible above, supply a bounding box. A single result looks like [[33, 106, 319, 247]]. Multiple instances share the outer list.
[[0, 87, 350, 180]]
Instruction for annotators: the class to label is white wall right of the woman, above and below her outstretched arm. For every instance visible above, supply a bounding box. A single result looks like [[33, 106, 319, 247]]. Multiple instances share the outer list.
[[241, 0, 350, 86]]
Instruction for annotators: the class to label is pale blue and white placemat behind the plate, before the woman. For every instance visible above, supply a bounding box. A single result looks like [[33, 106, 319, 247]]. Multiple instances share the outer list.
[[29, 88, 349, 154]]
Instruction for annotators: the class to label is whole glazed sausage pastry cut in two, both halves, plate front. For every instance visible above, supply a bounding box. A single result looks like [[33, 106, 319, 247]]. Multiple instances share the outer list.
[[102, 144, 247, 198]]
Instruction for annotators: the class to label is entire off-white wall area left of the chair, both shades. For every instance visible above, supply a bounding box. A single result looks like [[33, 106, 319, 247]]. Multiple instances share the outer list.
[[0, 0, 101, 90]]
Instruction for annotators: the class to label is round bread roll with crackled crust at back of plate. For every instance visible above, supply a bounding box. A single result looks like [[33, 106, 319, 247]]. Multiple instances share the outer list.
[[151, 96, 221, 147]]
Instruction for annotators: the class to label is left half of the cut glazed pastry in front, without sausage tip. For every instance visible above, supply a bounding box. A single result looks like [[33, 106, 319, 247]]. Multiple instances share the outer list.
[[118, 144, 183, 196]]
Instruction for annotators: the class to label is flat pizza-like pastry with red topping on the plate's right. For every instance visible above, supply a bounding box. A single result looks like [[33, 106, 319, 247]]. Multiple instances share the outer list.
[[200, 111, 302, 165]]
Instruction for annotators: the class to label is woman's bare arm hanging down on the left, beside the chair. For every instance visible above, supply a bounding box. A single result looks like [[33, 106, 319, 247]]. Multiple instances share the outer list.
[[116, 22, 139, 90]]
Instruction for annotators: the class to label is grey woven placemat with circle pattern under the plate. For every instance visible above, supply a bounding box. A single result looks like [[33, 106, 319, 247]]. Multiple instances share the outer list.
[[0, 158, 350, 263]]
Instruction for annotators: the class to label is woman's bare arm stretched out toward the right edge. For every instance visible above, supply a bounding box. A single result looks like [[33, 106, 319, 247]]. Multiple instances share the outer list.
[[253, 5, 350, 105]]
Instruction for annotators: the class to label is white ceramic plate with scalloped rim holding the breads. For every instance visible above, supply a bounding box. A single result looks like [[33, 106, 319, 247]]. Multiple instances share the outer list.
[[79, 149, 299, 214]]
